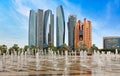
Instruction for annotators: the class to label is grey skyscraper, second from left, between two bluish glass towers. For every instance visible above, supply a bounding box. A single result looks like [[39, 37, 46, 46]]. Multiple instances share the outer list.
[[36, 9, 44, 47]]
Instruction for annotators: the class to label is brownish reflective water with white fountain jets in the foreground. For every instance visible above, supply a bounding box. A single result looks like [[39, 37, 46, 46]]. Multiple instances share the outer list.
[[0, 49, 120, 76]]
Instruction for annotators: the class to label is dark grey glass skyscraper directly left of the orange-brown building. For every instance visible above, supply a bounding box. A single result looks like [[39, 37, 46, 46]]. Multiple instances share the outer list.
[[68, 15, 76, 49]]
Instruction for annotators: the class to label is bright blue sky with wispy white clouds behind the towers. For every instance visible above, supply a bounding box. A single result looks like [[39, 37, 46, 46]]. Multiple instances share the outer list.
[[0, 0, 120, 48]]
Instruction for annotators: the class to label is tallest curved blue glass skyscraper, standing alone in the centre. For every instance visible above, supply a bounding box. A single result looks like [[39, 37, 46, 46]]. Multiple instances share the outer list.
[[56, 5, 65, 48]]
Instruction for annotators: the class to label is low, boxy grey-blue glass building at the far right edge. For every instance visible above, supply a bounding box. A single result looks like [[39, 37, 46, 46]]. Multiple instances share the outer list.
[[103, 36, 120, 49]]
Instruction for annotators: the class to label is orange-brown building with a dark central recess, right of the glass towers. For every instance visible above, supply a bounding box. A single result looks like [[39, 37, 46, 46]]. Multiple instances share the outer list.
[[74, 18, 92, 48]]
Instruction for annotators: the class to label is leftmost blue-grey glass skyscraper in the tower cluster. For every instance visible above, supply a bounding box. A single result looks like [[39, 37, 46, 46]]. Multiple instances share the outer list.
[[29, 10, 36, 46]]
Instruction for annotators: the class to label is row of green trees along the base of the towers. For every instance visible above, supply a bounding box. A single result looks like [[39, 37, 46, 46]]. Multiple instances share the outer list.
[[0, 43, 120, 55]]
